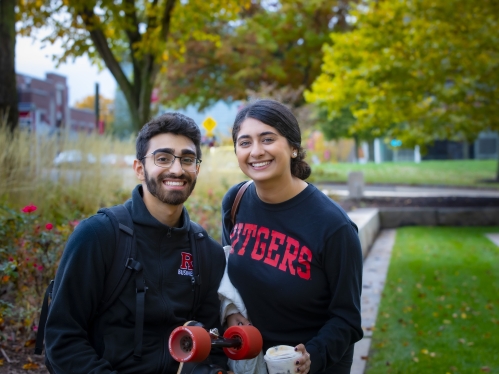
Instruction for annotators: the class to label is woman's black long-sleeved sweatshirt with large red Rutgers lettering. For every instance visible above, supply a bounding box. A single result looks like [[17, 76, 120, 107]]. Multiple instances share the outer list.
[[222, 184, 363, 374]]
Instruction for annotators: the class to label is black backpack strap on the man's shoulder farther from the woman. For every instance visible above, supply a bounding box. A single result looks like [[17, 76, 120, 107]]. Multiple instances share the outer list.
[[97, 205, 147, 361]]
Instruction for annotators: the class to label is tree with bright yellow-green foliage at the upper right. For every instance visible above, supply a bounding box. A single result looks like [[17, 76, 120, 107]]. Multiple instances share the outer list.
[[305, 0, 499, 177]]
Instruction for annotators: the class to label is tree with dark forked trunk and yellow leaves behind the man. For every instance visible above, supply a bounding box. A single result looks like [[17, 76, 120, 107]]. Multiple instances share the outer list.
[[19, 0, 250, 130]]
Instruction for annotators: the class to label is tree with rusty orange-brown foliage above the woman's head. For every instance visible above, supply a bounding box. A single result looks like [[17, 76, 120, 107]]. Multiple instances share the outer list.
[[160, 0, 358, 109]]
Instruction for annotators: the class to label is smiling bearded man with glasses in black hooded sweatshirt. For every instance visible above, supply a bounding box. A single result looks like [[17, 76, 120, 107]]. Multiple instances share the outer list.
[[45, 113, 227, 374]]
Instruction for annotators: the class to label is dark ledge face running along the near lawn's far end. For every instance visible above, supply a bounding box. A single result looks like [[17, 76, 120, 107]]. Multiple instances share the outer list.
[[379, 208, 499, 228]]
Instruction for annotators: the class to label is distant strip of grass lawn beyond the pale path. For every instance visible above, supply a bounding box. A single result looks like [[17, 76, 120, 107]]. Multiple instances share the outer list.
[[312, 160, 499, 188]]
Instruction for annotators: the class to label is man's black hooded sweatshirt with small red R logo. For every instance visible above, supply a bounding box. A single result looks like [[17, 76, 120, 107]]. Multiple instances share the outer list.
[[45, 186, 227, 374]]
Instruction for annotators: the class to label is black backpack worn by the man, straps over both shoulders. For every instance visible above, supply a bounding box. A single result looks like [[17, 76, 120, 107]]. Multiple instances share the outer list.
[[35, 205, 210, 361]]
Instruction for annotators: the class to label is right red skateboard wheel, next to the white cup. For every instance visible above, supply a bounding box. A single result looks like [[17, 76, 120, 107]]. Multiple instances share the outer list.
[[223, 326, 263, 360]]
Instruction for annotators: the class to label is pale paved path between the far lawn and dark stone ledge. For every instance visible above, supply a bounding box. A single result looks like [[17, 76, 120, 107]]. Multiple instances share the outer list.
[[316, 183, 499, 198]]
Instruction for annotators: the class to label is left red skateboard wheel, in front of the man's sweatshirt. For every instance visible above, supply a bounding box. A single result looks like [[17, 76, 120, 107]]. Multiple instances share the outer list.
[[168, 326, 211, 362]]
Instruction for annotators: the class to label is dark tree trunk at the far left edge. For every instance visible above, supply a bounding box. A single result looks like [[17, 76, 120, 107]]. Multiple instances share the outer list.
[[0, 0, 19, 130]]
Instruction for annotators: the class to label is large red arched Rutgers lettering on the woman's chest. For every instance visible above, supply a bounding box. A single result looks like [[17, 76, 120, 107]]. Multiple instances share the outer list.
[[230, 223, 312, 280]]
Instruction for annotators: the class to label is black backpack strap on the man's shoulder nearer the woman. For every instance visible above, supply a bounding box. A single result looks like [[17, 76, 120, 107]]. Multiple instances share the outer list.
[[189, 221, 211, 320]]
